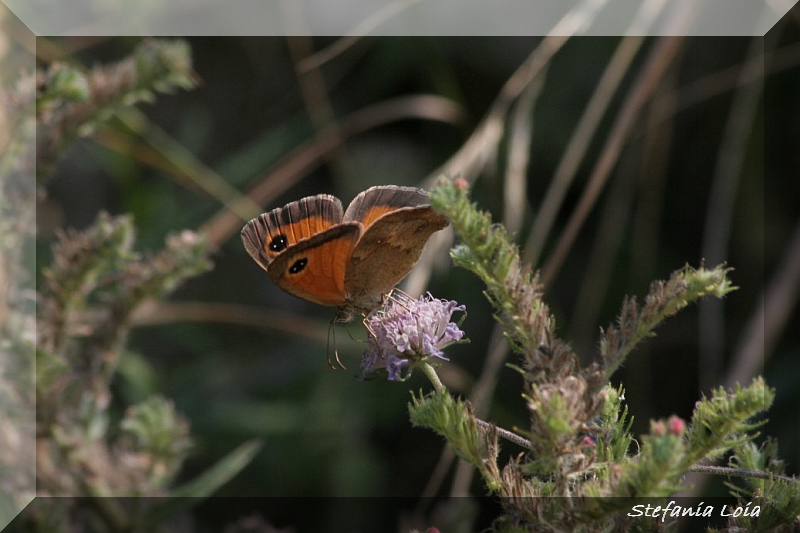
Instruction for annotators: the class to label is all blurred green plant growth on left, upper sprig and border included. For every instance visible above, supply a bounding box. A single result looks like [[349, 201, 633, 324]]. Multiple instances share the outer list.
[[8, 39, 259, 531]]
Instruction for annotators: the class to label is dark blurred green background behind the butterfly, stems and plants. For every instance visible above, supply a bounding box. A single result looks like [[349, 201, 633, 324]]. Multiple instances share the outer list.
[[25, 22, 800, 524]]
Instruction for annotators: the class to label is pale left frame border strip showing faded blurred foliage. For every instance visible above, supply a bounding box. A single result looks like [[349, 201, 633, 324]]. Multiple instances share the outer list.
[[0, 32, 36, 528]]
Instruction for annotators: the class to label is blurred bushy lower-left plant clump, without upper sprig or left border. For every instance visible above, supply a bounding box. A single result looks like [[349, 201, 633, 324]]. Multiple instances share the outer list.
[[31, 213, 259, 531]]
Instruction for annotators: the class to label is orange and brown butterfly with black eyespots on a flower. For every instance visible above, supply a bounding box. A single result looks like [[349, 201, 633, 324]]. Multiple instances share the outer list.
[[242, 185, 447, 322]]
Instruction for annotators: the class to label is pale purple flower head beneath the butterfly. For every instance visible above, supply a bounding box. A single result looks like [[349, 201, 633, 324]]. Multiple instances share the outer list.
[[361, 293, 466, 381]]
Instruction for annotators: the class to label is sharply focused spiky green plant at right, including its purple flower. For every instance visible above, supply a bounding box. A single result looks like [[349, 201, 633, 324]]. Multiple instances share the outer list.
[[363, 178, 800, 531]]
